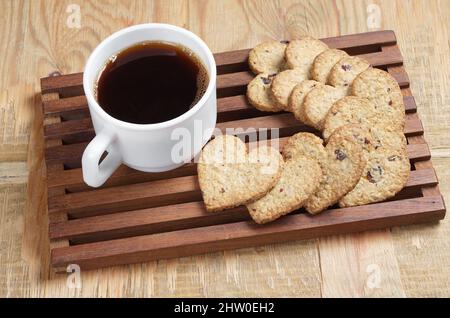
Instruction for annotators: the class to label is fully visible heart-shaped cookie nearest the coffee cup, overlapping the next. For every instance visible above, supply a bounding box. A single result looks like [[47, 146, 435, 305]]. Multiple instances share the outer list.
[[197, 135, 283, 211]]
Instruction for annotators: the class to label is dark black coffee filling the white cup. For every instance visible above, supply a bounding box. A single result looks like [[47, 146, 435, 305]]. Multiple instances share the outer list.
[[96, 42, 209, 124]]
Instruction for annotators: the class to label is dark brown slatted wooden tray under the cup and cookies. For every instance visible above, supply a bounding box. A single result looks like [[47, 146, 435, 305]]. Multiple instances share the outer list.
[[41, 31, 445, 270]]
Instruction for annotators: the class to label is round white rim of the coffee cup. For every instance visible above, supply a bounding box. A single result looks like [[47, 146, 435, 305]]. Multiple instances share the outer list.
[[83, 23, 217, 130]]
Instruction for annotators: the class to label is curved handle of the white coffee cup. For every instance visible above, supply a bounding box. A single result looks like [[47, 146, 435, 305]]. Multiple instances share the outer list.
[[81, 130, 122, 187]]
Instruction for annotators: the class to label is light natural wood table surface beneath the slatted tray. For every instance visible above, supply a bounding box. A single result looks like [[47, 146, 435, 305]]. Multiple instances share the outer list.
[[0, 0, 450, 297]]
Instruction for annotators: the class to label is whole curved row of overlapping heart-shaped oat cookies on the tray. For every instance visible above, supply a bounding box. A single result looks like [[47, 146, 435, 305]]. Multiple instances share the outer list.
[[198, 36, 410, 223]]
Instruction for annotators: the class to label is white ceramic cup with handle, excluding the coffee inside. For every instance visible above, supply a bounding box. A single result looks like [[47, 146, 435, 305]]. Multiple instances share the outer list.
[[82, 23, 217, 187]]
